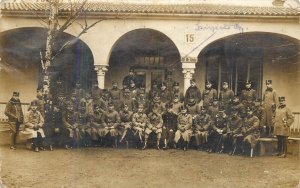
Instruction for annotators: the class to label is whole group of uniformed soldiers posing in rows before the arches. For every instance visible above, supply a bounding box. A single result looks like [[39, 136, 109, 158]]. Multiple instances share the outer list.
[[5, 71, 293, 157]]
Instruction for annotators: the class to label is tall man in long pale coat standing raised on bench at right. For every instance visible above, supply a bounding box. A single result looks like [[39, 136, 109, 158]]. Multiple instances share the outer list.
[[261, 80, 278, 137]]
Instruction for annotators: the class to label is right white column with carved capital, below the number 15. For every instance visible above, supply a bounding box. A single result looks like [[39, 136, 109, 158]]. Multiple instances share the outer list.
[[181, 57, 198, 93]]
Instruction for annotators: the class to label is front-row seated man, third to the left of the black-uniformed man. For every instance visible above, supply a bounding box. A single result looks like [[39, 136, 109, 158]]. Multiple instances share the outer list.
[[118, 103, 133, 148]]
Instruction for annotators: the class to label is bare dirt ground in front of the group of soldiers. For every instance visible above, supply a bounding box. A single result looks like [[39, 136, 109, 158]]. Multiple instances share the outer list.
[[0, 146, 300, 188]]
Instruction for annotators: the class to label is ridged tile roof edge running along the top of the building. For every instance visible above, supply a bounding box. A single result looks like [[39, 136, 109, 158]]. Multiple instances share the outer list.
[[1, 2, 300, 16]]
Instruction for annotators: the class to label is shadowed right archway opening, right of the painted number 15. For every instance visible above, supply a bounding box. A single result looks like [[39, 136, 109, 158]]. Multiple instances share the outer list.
[[196, 31, 300, 109]]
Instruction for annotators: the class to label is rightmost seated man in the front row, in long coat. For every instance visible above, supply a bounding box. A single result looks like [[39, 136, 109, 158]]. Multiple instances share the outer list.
[[242, 107, 259, 157]]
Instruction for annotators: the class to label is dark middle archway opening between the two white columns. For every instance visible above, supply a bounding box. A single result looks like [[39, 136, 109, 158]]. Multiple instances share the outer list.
[[105, 28, 183, 92]]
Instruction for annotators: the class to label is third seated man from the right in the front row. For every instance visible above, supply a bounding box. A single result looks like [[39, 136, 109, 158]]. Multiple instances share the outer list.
[[209, 106, 228, 153]]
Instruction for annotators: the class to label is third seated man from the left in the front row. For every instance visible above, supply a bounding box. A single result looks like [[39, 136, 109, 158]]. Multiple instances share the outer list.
[[63, 102, 79, 149]]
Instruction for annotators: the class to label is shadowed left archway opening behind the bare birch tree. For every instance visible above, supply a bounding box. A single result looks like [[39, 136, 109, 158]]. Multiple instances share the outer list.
[[0, 27, 96, 102]]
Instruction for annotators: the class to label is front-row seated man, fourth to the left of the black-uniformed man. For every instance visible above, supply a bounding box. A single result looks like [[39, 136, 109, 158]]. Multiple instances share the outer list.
[[103, 103, 121, 147]]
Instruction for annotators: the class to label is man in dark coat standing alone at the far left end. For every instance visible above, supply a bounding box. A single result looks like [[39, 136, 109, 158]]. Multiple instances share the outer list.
[[4, 91, 23, 150]]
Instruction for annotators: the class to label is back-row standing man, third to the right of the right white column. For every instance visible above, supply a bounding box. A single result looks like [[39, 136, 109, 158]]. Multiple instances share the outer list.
[[219, 82, 234, 114]]
